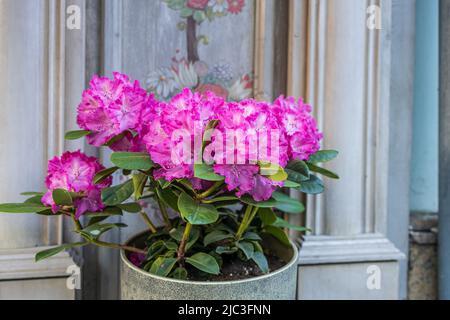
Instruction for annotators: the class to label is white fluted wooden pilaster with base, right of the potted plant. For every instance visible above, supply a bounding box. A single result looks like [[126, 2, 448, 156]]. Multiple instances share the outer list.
[[288, 0, 414, 298]]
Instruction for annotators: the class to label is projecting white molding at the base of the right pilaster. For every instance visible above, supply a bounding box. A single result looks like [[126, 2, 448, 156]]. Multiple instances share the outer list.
[[299, 233, 406, 265]]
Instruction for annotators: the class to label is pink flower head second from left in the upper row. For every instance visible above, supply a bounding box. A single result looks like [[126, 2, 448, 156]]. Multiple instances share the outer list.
[[143, 88, 224, 181]]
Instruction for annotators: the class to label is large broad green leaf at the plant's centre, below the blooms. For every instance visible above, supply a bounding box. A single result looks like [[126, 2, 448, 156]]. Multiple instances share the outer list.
[[178, 192, 219, 225]]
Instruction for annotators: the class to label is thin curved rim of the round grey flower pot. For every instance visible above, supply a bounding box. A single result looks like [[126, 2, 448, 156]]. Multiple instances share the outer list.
[[120, 231, 298, 285]]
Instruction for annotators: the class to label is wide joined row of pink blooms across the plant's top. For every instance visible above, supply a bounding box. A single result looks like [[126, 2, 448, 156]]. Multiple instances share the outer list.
[[78, 73, 322, 201]]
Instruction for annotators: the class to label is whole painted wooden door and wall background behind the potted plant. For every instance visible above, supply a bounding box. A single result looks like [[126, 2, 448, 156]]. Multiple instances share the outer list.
[[0, 0, 442, 299]]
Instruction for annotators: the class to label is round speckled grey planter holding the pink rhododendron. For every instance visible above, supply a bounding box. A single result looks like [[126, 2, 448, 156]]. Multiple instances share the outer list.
[[120, 233, 298, 300]]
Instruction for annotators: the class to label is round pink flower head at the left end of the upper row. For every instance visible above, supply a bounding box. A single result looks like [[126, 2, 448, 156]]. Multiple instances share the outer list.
[[77, 72, 151, 147]]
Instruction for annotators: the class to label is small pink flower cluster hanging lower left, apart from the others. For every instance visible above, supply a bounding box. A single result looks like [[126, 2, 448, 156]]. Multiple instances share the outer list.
[[42, 151, 112, 218]]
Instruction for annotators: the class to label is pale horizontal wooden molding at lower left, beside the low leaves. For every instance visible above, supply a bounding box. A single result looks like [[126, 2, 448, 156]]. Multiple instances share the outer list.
[[0, 247, 75, 281]]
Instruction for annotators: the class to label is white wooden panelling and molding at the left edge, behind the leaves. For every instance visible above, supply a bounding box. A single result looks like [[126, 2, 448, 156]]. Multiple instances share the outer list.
[[0, 0, 85, 299]]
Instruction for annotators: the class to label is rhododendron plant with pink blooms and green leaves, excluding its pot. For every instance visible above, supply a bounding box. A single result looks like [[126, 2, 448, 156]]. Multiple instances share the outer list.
[[0, 72, 338, 279]]
